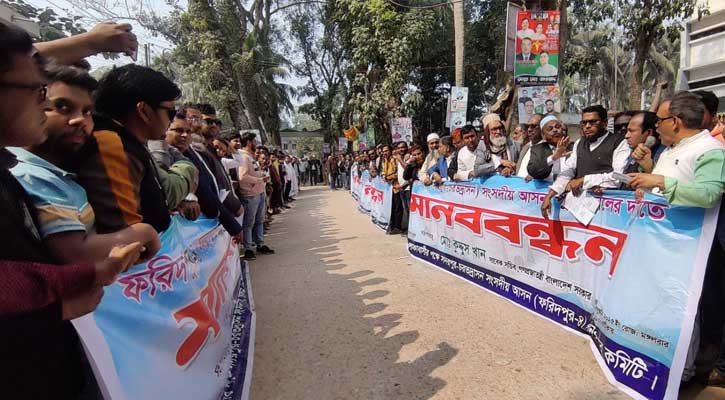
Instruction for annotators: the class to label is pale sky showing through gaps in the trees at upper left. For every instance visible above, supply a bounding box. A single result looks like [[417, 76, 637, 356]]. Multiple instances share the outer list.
[[25, 0, 309, 109]]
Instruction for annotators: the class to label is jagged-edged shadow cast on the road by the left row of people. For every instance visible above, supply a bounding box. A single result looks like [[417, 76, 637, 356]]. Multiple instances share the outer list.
[[251, 188, 458, 399]]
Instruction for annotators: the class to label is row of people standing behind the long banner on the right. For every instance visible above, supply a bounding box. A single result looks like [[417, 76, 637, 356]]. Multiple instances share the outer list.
[[346, 82, 725, 387]]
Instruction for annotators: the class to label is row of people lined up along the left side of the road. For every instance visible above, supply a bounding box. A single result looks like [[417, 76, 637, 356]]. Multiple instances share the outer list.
[[0, 23, 301, 399]]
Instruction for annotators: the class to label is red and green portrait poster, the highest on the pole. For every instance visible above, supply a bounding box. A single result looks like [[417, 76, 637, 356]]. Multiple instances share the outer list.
[[514, 11, 561, 85]]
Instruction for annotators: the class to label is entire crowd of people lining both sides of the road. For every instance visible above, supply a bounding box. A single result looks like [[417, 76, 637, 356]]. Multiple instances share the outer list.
[[0, 10, 725, 398]]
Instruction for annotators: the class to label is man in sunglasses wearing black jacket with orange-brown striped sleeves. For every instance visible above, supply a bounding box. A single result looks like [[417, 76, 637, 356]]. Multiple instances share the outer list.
[[73, 64, 198, 233]]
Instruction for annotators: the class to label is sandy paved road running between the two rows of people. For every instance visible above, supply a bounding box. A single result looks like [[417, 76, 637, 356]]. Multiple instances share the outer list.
[[251, 187, 725, 400]]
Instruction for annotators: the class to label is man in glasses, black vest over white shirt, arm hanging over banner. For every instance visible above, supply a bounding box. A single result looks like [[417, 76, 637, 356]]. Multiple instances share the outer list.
[[541, 105, 632, 218]]
